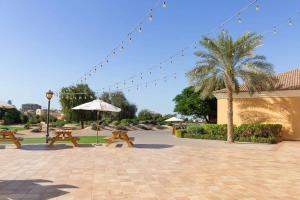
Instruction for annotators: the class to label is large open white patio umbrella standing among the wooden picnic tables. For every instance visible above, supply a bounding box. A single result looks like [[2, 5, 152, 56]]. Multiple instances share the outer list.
[[72, 99, 121, 144]]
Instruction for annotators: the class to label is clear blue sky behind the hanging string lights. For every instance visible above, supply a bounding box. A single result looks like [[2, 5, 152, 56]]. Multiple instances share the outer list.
[[0, 0, 300, 113]]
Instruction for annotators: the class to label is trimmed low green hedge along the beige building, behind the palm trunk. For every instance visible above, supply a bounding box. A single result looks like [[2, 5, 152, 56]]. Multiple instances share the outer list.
[[181, 124, 282, 143]]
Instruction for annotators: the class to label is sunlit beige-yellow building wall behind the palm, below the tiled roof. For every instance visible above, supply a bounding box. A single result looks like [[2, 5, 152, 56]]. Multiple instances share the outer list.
[[216, 91, 300, 140]]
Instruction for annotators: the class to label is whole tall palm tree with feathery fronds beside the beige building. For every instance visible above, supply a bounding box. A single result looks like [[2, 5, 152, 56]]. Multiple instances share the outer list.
[[187, 32, 274, 143]]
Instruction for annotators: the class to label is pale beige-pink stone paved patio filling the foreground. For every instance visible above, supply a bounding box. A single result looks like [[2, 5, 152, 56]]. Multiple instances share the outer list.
[[0, 130, 300, 200]]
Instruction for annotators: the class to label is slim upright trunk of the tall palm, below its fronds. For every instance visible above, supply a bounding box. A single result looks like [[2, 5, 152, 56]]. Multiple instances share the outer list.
[[227, 89, 233, 143]]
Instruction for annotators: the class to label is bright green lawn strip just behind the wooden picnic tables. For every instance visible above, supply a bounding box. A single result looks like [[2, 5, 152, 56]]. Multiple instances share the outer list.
[[0, 136, 105, 144]]
